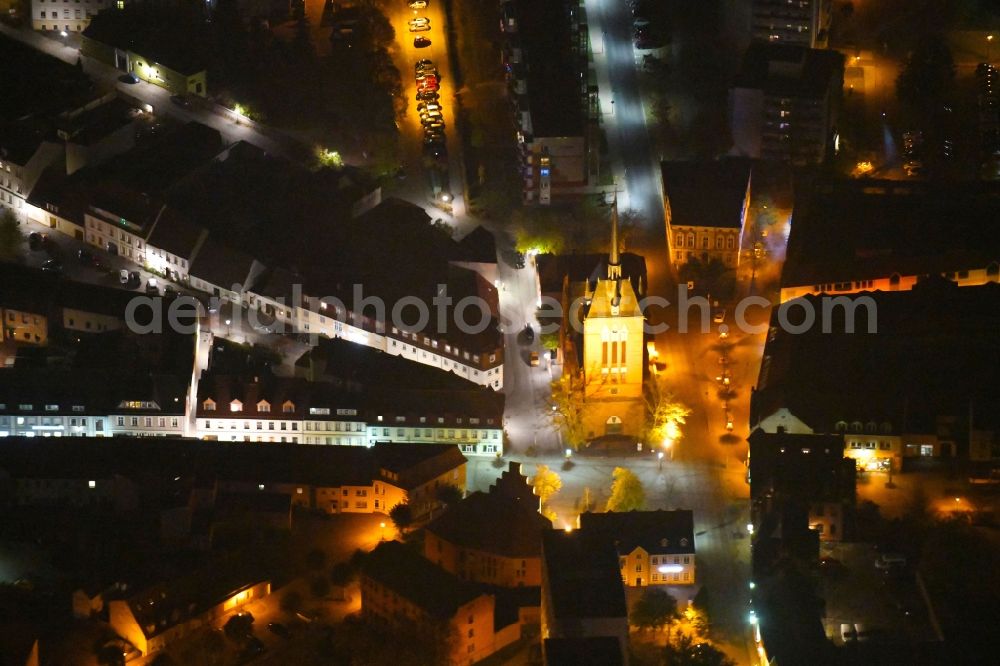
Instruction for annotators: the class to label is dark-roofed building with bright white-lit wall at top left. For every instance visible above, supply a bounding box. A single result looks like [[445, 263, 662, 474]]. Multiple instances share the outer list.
[[80, 3, 208, 97]]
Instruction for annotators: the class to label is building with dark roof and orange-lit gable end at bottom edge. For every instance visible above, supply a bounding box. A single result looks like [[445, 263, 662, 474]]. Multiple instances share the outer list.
[[361, 541, 521, 665]]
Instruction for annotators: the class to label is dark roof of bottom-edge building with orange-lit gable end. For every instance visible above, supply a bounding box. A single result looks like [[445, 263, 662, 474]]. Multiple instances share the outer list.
[[363, 541, 483, 620]]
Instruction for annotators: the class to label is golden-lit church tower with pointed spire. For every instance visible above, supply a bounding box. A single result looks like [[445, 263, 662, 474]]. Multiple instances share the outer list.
[[583, 200, 644, 437]]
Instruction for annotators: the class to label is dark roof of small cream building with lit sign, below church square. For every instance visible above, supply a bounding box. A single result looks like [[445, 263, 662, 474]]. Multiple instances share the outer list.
[[580, 509, 695, 555]]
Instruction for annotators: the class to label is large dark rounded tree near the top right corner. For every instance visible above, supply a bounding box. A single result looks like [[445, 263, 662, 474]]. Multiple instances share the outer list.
[[896, 35, 955, 111]]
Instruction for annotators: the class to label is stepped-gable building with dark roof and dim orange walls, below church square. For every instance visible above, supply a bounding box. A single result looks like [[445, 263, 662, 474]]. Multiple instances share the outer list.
[[424, 463, 552, 587]]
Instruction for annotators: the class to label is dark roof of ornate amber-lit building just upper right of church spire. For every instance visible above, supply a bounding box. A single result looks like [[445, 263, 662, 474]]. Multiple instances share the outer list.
[[660, 159, 750, 229]]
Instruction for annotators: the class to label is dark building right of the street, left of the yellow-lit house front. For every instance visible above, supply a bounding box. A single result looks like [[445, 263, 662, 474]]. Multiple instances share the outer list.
[[749, 430, 856, 541]]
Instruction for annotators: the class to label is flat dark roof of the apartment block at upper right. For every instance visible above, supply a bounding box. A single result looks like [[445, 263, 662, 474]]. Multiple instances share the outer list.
[[733, 42, 844, 99]]
